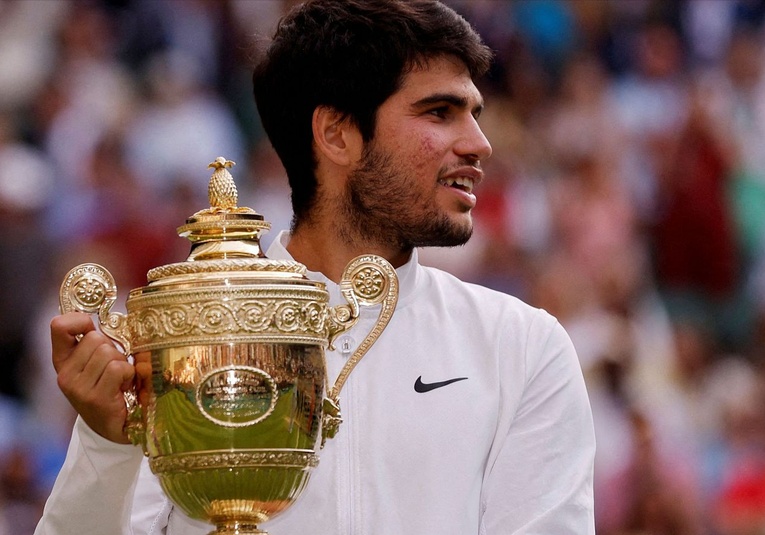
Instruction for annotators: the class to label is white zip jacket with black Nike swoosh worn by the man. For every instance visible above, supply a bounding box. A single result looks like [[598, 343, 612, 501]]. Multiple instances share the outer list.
[[35, 233, 595, 535]]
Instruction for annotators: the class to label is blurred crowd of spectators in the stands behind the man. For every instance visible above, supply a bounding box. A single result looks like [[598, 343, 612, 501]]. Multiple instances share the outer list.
[[0, 0, 765, 535]]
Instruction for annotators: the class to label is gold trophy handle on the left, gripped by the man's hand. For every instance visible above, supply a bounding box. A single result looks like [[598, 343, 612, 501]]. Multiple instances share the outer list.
[[59, 263, 143, 444]]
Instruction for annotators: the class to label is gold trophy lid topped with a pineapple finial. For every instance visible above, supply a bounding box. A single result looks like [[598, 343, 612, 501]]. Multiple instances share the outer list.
[[147, 156, 305, 283]]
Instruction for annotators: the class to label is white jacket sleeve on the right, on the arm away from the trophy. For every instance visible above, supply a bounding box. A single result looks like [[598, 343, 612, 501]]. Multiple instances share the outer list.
[[481, 311, 595, 535]]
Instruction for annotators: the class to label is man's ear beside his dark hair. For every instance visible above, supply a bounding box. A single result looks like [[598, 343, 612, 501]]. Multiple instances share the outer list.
[[311, 106, 362, 166]]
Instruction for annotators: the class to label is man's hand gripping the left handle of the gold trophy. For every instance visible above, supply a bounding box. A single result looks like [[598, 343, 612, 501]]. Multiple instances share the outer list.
[[50, 312, 135, 444]]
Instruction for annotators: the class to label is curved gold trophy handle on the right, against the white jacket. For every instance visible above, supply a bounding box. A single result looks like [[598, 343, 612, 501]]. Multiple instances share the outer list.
[[321, 255, 398, 447]]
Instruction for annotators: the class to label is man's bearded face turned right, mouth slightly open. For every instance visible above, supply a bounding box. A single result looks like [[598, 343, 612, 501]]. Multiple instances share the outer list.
[[342, 57, 491, 250]]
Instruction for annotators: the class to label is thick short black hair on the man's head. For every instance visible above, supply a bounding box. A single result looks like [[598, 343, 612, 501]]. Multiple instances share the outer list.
[[253, 0, 491, 228]]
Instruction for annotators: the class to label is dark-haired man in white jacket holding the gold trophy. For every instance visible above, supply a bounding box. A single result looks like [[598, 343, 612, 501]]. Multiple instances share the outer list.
[[37, 0, 594, 535]]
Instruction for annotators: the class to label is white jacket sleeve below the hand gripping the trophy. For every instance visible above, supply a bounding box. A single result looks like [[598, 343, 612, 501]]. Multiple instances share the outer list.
[[35, 417, 148, 535]]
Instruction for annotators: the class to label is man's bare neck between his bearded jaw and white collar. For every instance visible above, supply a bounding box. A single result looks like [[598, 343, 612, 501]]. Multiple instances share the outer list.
[[287, 225, 411, 282]]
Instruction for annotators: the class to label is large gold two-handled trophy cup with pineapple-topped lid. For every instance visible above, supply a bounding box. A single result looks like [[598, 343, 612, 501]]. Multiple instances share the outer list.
[[60, 158, 398, 535]]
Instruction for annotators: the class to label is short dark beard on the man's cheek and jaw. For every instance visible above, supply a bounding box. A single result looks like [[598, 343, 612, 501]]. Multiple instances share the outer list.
[[339, 145, 473, 251]]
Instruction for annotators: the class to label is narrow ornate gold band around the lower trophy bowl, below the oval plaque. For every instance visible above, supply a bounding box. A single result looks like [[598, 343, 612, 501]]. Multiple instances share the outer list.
[[149, 450, 319, 474]]
